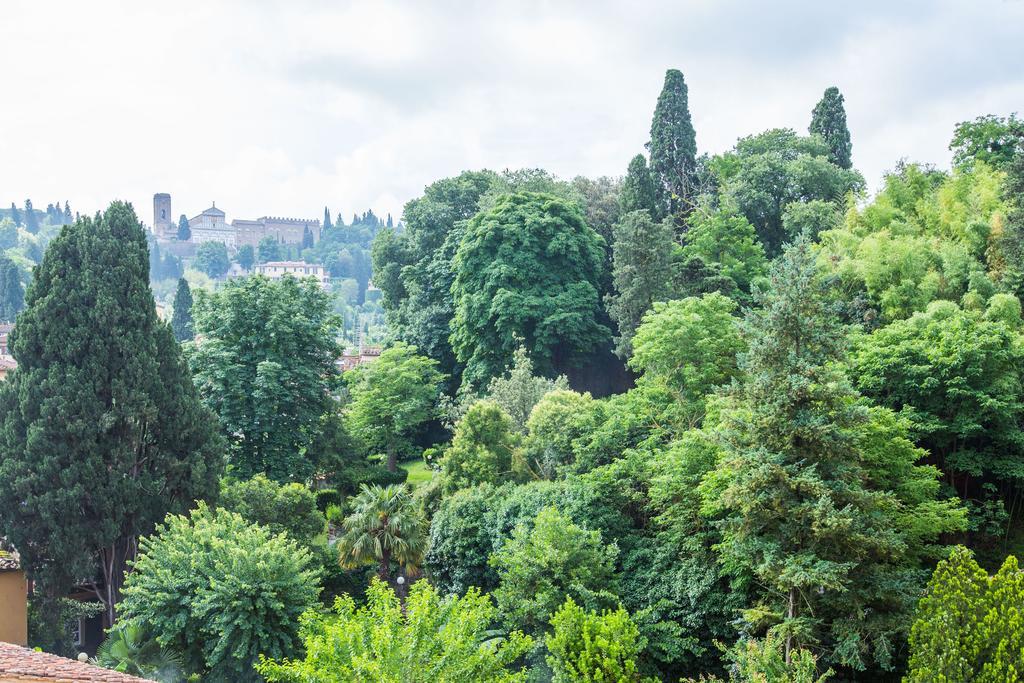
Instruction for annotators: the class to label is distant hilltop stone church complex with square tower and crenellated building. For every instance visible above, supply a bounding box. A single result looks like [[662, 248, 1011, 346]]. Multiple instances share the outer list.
[[153, 193, 321, 249]]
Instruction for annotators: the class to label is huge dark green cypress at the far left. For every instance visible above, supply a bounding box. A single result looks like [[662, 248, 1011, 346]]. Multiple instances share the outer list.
[[0, 202, 223, 626]]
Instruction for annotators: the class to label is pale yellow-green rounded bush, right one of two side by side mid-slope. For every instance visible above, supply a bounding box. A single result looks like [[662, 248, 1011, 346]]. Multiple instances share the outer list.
[[523, 389, 600, 479]]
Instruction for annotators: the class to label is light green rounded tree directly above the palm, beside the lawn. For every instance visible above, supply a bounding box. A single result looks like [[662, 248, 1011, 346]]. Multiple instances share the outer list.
[[345, 342, 444, 472]]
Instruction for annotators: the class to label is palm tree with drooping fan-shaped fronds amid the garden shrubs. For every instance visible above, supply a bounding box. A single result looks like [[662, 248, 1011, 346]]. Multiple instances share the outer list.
[[338, 484, 427, 582]]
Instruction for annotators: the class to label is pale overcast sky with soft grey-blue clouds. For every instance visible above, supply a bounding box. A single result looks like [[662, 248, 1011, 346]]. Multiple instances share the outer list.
[[0, 0, 1024, 223]]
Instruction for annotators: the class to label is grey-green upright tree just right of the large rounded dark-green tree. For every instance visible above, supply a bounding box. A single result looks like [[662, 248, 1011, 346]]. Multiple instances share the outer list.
[[605, 211, 676, 359]]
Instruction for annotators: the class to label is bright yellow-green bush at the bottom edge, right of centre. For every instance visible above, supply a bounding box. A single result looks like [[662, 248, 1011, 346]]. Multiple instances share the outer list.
[[544, 598, 644, 683]]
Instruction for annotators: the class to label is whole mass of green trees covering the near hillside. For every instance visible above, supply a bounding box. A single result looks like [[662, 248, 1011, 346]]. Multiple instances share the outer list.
[[0, 70, 1024, 683]]
